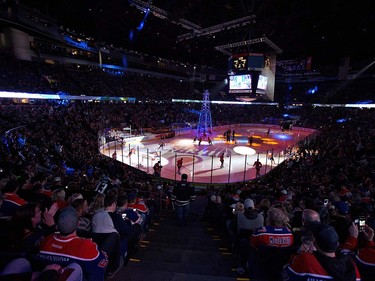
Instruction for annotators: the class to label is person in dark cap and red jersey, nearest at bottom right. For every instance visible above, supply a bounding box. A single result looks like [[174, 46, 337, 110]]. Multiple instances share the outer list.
[[283, 223, 361, 281]]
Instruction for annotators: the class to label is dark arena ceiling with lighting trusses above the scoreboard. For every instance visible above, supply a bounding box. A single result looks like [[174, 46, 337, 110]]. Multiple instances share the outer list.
[[19, 0, 375, 71]]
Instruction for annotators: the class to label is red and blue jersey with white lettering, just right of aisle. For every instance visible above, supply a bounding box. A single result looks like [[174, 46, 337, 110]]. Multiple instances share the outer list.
[[250, 225, 294, 248]]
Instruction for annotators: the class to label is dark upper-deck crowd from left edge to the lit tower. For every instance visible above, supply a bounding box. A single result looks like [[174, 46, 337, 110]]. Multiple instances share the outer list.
[[0, 54, 203, 101]]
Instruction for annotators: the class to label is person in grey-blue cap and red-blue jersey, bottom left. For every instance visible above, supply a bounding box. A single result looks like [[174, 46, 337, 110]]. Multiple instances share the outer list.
[[35, 206, 108, 281]]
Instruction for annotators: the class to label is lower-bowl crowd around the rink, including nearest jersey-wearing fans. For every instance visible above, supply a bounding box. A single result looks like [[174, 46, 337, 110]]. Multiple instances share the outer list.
[[0, 54, 375, 280]]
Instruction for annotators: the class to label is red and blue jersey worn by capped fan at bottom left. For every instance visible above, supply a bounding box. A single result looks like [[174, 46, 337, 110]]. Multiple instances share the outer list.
[[37, 234, 108, 281]]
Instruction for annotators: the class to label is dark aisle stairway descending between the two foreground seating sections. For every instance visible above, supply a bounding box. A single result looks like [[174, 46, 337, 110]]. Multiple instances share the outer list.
[[110, 196, 241, 281]]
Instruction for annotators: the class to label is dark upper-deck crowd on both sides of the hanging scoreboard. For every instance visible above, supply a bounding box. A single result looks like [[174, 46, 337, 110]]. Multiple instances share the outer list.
[[0, 51, 374, 103]]
